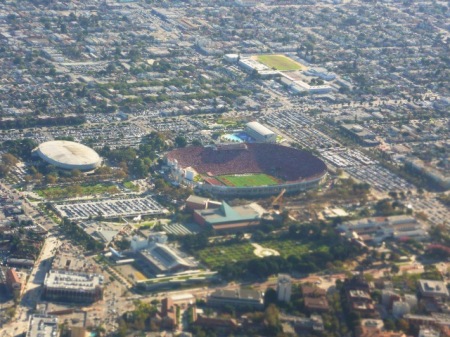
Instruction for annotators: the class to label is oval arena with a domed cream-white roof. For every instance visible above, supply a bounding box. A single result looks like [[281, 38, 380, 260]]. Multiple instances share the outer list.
[[35, 140, 101, 171]]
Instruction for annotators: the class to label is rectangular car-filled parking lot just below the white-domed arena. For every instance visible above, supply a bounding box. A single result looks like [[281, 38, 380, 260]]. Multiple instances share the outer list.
[[54, 197, 166, 220]]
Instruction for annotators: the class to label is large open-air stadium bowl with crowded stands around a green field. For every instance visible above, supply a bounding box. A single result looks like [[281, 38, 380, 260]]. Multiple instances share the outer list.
[[166, 143, 327, 197]]
